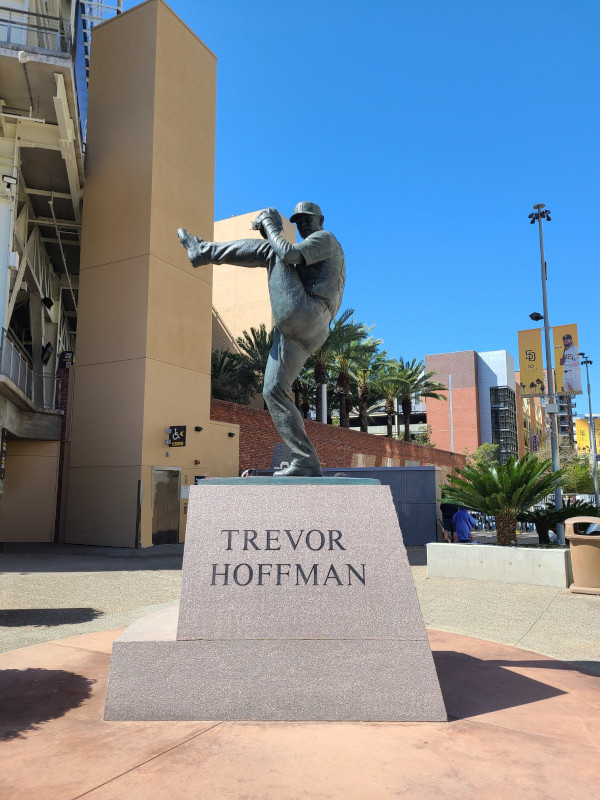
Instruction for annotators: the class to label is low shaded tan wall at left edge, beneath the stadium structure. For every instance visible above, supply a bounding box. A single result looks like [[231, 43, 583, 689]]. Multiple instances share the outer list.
[[0, 439, 60, 542]]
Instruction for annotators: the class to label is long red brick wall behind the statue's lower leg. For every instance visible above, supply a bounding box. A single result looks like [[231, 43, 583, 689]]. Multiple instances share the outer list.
[[210, 400, 465, 482]]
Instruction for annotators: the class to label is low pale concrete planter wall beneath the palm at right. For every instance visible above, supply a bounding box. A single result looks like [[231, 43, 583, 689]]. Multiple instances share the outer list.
[[427, 542, 571, 588]]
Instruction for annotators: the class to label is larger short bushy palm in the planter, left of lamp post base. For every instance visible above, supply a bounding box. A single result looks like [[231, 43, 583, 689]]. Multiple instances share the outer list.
[[442, 454, 562, 545]]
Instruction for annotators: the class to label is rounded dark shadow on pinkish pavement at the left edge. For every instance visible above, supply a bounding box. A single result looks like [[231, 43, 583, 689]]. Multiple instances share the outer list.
[[0, 668, 95, 741]]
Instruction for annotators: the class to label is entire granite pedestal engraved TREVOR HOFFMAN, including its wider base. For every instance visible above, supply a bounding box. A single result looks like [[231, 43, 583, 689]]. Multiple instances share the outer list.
[[105, 478, 446, 721]]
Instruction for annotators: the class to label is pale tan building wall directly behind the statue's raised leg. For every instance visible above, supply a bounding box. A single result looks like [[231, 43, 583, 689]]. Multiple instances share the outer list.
[[213, 211, 296, 348]]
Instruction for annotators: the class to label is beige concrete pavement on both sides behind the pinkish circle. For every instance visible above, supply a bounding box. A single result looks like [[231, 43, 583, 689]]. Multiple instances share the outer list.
[[0, 544, 600, 674]]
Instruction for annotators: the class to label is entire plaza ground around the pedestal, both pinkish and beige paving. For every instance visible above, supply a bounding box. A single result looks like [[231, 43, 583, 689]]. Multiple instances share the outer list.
[[0, 546, 600, 800]]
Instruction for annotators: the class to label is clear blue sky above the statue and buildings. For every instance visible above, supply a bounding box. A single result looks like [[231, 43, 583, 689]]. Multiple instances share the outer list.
[[126, 0, 600, 414]]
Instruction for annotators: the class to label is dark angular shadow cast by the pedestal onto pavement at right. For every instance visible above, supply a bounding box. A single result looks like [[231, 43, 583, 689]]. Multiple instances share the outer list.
[[433, 650, 568, 719]]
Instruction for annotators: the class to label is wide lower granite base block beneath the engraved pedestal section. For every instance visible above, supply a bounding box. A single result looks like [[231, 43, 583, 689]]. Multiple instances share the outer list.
[[104, 606, 446, 722]]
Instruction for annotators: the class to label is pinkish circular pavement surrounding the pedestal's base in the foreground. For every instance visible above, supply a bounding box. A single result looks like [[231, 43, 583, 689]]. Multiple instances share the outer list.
[[0, 631, 600, 800]]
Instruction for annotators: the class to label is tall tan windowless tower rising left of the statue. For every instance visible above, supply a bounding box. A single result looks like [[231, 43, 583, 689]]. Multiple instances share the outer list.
[[65, 0, 220, 547]]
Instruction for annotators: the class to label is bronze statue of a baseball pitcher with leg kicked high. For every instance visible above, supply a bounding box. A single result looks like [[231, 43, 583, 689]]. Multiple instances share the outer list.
[[178, 202, 346, 477]]
